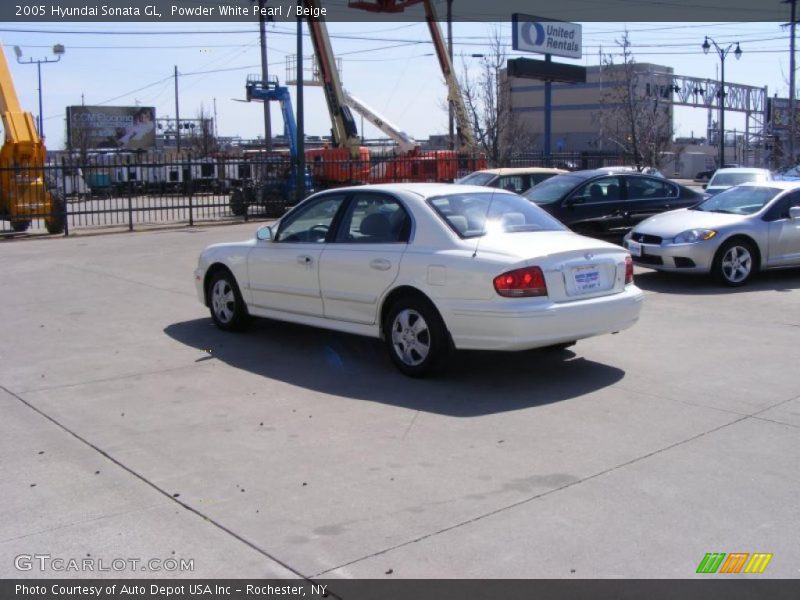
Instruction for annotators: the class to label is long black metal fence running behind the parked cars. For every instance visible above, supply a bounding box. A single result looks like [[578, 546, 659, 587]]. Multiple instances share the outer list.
[[0, 151, 630, 235]]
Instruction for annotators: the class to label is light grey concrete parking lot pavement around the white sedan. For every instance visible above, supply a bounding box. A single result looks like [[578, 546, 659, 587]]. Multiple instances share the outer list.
[[0, 223, 800, 578]]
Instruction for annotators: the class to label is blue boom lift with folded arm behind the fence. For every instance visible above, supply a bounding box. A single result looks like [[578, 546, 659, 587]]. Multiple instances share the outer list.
[[230, 75, 315, 217]]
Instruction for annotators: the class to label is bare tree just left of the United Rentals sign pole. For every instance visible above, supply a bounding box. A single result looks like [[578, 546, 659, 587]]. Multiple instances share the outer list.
[[461, 29, 537, 167]]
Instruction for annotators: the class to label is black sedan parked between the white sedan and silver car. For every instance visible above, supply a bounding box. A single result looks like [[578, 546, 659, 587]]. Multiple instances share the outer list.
[[523, 168, 703, 236]]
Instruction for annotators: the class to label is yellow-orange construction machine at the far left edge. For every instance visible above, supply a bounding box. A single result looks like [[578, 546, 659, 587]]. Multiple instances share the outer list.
[[0, 45, 64, 234]]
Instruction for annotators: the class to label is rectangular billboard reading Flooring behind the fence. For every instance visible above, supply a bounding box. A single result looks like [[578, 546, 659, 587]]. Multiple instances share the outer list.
[[67, 106, 156, 150]]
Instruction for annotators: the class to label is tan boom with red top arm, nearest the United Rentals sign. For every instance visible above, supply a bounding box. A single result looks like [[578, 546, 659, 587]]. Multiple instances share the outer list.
[[348, 0, 476, 151]]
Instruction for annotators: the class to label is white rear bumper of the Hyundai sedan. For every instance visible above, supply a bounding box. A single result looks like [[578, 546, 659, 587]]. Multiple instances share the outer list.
[[442, 285, 644, 350]]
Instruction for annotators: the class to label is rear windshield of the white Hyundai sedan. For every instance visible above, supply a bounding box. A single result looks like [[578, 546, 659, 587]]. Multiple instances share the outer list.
[[428, 192, 566, 238]]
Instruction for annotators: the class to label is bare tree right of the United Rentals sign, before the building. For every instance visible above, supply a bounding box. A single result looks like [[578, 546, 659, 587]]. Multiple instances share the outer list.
[[595, 31, 674, 168]]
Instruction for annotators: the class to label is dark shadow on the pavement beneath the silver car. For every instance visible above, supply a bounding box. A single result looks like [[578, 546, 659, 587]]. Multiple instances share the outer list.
[[634, 269, 800, 296]]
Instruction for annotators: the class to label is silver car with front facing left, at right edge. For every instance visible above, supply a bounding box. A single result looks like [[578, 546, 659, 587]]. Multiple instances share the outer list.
[[624, 181, 800, 286]]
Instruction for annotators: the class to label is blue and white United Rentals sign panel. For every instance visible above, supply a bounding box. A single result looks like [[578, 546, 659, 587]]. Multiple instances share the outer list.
[[511, 13, 583, 58]]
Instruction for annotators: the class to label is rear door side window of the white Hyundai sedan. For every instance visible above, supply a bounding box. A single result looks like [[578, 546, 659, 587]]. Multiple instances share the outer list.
[[336, 193, 411, 244]]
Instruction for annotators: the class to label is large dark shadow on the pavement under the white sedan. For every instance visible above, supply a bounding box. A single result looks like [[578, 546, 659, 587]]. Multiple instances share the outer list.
[[164, 318, 625, 417]]
